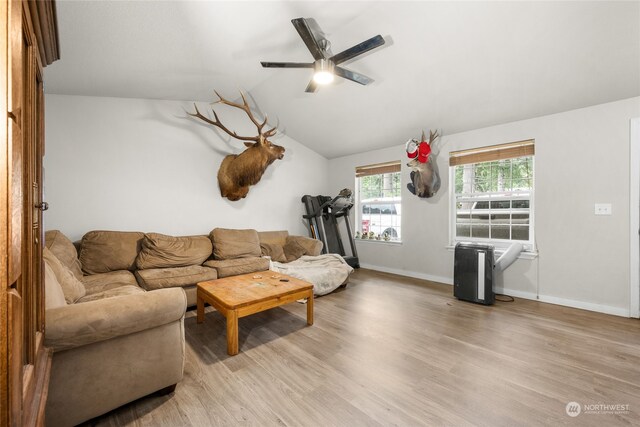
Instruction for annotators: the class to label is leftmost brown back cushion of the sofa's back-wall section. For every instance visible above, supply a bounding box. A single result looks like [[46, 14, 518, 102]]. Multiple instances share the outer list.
[[80, 231, 144, 274]]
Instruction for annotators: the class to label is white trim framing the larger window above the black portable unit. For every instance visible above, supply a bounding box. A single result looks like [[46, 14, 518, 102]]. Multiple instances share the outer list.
[[447, 155, 538, 255]]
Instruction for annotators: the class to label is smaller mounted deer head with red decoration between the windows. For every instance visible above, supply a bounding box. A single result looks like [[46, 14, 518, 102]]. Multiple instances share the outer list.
[[406, 131, 440, 198]]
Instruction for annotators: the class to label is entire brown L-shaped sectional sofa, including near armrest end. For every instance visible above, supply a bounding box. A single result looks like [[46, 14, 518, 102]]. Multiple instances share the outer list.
[[44, 228, 322, 426]]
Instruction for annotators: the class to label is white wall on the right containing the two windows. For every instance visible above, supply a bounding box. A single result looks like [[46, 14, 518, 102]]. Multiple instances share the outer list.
[[329, 98, 640, 316]]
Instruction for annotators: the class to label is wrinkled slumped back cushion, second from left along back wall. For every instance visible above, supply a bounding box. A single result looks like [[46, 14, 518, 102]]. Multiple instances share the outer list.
[[136, 233, 213, 270]]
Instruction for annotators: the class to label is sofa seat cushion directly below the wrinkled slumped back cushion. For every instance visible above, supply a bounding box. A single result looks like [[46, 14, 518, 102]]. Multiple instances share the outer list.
[[136, 265, 218, 291]]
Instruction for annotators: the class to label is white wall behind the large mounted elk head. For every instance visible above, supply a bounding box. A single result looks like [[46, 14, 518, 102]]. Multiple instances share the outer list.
[[44, 94, 328, 240]]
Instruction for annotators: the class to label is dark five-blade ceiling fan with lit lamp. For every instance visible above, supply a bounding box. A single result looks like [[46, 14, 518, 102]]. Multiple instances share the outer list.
[[260, 18, 384, 93]]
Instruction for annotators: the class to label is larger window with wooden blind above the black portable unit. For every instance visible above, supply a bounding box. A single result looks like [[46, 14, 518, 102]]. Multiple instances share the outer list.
[[449, 140, 534, 250]]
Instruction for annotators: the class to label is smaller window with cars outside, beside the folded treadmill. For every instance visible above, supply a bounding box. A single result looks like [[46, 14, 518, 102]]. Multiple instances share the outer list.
[[356, 161, 402, 241]]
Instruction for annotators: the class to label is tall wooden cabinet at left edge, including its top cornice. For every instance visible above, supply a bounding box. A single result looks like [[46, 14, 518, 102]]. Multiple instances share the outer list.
[[0, 0, 58, 426]]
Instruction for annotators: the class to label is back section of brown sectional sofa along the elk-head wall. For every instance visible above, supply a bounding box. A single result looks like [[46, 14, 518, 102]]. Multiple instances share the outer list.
[[46, 228, 322, 306]]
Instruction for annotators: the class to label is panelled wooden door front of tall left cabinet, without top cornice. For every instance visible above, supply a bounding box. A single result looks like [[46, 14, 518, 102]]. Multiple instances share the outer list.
[[3, 0, 50, 426]]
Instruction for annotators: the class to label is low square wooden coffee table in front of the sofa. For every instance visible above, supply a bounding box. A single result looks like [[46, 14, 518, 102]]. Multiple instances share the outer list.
[[197, 271, 313, 356]]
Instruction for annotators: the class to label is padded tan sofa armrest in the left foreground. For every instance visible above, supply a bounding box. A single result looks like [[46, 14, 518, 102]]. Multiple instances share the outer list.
[[45, 288, 187, 351]]
